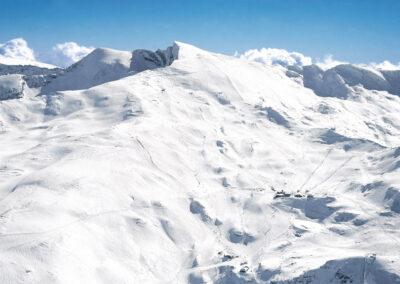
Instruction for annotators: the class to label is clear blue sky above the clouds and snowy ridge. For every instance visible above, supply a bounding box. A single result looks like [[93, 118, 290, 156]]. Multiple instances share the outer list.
[[0, 0, 400, 63]]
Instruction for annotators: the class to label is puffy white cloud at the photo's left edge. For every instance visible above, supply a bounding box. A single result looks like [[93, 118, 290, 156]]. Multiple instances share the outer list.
[[0, 38, 35, 61]]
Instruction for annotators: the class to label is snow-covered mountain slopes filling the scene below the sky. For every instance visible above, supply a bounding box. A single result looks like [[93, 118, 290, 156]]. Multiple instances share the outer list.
[[0, 43, 400, 283]]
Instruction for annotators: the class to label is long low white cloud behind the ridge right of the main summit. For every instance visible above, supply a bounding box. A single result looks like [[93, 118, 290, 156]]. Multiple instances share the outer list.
[[235, 48, 312, 66]]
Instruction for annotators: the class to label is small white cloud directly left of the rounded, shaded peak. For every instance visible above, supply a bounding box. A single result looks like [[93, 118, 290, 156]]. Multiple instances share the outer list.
[[50, 42, 94, 67]]
